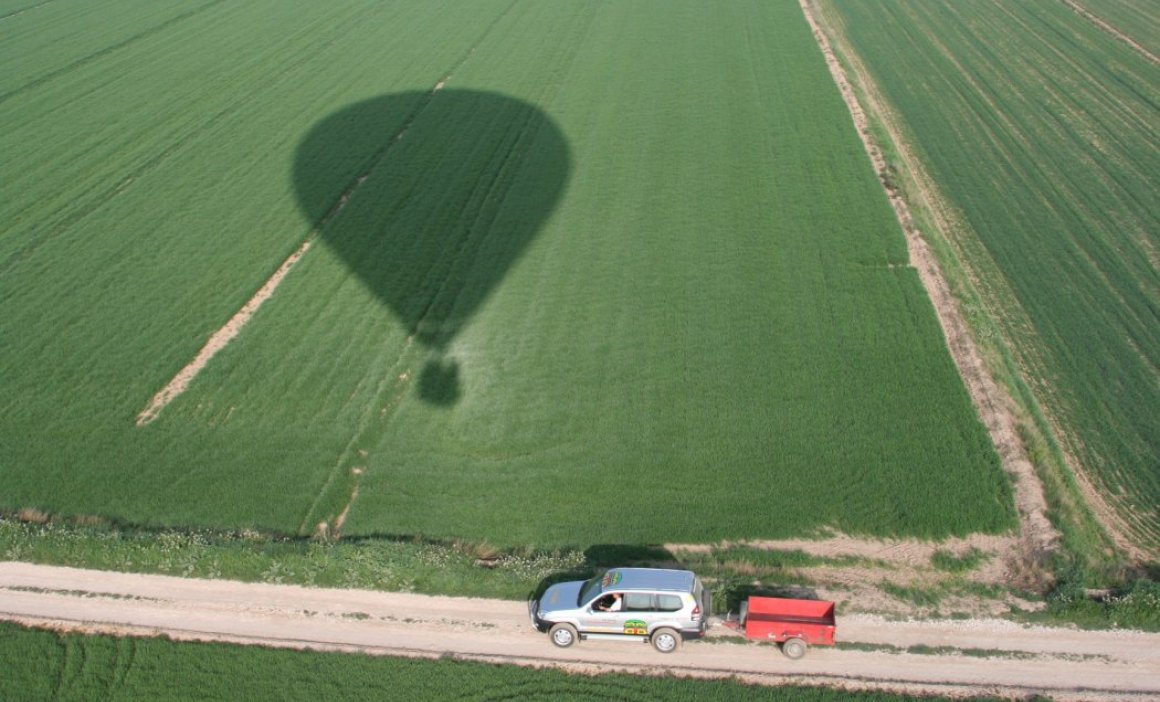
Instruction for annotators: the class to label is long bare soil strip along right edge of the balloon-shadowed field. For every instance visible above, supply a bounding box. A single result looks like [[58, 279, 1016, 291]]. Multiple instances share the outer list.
[[799, 0, 1059, 563]]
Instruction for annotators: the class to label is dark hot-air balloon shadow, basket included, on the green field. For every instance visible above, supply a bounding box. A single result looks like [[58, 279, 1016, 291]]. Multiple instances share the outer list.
[[293, 89, 570, 405]]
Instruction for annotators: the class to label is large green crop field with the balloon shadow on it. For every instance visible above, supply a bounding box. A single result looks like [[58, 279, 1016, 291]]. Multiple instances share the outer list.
[[0, 0, 1015, 548]]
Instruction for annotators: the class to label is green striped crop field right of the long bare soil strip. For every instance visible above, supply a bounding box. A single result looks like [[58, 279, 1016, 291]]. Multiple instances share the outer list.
[[833, 0, 1160, 544]]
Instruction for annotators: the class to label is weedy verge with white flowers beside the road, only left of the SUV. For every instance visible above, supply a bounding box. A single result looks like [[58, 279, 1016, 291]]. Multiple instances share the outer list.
[[0, 519, 580, 599]]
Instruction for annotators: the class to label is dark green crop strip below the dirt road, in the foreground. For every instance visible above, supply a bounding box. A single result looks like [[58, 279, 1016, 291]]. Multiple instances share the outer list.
[[0, 622, 944, 702]]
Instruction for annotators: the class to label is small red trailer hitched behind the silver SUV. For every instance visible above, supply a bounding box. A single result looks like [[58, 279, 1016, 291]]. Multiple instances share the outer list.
[[725, 595, 835, 658]]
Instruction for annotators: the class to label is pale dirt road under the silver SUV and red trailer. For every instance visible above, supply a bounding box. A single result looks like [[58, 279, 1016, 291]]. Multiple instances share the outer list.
[[0, 563, 1160, 700]]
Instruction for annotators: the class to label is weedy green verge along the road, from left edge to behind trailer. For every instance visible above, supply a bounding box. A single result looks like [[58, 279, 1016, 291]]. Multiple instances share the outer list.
[[0, 514, 839, 611]]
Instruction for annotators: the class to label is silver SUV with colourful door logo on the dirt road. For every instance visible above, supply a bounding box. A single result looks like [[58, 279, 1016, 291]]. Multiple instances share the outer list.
[[529, 567, 711, 653]]
